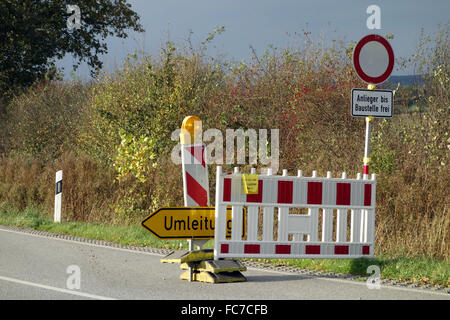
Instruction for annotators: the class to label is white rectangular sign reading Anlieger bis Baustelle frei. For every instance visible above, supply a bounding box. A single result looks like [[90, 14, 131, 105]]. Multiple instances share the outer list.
[[352, 89, 394, 118]]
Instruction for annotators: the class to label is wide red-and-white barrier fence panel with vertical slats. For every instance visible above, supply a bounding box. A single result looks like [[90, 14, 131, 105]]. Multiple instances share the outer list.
[[214, 166, 376, 260]]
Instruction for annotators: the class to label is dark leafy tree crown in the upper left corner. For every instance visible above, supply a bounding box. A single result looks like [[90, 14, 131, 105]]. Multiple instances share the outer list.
[[0, 0, 144, 95]]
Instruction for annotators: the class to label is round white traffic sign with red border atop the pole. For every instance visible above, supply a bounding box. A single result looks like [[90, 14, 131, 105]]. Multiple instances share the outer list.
[[353, 34, 394, 84]]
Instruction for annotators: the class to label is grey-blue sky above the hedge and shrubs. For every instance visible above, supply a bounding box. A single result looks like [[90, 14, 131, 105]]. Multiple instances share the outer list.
[[57, 0, 450, 79]]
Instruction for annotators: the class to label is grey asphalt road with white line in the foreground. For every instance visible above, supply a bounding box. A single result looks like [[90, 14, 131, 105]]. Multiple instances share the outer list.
[[0, 227, 450, 300]]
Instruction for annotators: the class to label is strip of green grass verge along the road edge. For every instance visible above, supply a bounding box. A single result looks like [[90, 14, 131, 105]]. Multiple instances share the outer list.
[[0, 204, 450, 287]]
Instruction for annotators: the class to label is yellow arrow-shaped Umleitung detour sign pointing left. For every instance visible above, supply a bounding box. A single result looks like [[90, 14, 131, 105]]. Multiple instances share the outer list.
[[141, 207, 246, 239]]
